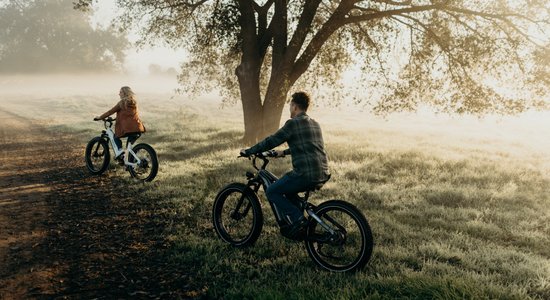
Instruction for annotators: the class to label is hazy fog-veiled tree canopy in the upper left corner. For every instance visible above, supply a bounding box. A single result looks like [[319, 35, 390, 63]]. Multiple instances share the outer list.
[[0, 0, 128, 73]]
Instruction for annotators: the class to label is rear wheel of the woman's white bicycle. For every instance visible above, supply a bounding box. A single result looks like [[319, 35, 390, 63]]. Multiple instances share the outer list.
[[128, 144, 159, 181]]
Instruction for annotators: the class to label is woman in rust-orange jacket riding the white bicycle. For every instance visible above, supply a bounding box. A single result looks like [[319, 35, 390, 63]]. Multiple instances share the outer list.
[[94, 86, 145, 160]]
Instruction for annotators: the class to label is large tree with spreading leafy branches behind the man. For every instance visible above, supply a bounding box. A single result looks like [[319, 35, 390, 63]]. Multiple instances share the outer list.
[[77, 0, 550, 140]]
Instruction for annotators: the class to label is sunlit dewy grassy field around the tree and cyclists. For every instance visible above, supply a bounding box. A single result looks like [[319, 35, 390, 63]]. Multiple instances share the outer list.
[[0, 77, 550, 299]]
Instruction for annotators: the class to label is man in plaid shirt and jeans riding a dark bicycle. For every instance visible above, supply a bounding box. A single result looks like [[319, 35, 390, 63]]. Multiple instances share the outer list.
[[241, 92, 330, 239]]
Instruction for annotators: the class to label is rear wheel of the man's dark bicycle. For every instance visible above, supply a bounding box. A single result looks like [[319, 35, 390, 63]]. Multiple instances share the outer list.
[[305, 200, 374, 272]]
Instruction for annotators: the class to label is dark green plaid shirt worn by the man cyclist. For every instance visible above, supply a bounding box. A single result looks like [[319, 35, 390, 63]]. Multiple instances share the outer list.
[[246, 113, 330, 182]]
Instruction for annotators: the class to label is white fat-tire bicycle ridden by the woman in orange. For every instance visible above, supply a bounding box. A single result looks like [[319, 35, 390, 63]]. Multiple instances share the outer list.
[[86, 117, 158, 181]]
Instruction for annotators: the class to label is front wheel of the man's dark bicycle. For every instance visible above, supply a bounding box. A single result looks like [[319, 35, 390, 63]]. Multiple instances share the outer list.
[[212, 183, 263, 247]]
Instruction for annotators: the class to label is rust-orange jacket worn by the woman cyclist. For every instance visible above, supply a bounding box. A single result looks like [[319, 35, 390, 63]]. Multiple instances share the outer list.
[[99, 100, 145, 138]]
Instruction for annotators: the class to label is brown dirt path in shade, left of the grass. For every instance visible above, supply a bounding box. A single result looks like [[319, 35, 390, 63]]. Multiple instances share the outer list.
[[0, 109, 200, 299]]
